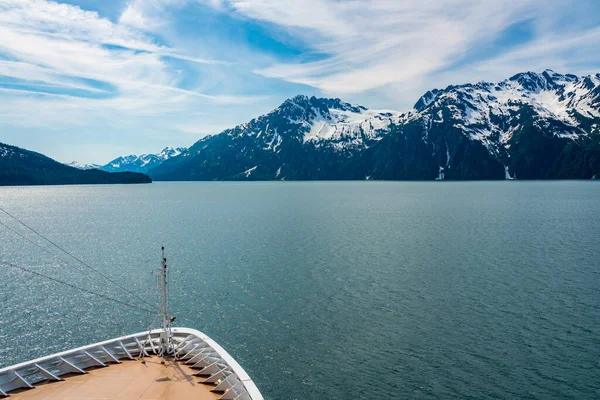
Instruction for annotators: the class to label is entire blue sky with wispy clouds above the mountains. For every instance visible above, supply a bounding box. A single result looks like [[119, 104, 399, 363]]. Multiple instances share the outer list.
[[0, 0, 600, 164]]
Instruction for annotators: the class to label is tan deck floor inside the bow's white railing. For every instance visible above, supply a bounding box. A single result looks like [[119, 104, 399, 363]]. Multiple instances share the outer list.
[[9, 357, 220, 400]]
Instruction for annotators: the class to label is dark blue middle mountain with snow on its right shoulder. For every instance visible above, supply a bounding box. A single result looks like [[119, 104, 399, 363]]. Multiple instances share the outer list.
[[152, 95, 401, 180]]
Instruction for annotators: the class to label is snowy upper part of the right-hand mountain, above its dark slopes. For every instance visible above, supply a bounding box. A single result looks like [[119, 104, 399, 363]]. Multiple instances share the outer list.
[[398, 70, 600, 161]]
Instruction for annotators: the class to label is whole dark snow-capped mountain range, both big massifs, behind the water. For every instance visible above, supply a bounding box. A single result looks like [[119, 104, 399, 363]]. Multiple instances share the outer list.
[[150, 70, 600, 180]]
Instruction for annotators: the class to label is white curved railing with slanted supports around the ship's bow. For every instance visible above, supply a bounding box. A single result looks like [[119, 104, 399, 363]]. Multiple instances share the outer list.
[[0, 328, 263, 400]]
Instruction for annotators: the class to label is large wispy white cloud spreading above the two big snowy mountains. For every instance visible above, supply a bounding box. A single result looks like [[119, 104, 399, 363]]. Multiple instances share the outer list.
[[231, 0, 536, 93]]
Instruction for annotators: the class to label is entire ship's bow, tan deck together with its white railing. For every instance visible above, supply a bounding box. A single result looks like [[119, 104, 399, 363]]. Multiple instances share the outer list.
[[0, 328, 263, 400]]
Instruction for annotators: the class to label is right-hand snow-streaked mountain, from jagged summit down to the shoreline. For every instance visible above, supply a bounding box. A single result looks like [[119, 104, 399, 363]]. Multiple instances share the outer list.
[[386, 70, 600, 179]]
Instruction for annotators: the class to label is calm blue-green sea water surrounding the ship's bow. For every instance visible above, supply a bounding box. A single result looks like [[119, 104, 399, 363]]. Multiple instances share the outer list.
[[0, 182, 600, 400]]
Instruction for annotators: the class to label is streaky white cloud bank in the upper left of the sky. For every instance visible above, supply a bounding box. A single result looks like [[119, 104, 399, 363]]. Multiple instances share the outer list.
[[0, 0, 251, 119]]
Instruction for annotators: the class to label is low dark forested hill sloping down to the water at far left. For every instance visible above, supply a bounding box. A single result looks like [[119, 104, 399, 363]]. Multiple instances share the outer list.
[[0, 143, 152, 186]]
